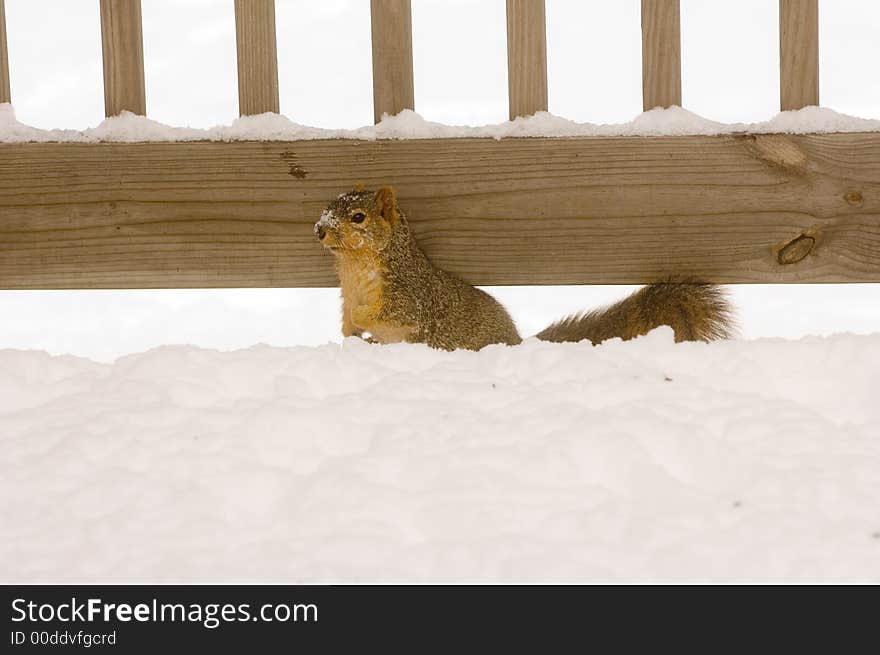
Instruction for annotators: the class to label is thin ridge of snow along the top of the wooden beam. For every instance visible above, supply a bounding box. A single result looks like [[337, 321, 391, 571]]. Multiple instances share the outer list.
[[0, 104, 880, 143]]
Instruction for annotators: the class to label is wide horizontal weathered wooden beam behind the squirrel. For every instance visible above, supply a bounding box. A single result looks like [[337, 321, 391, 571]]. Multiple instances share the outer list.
[[0, 133, 880, 289]]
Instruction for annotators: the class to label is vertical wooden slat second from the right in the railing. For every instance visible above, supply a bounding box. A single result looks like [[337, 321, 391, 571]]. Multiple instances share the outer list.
[[642, 0, 681, 111]]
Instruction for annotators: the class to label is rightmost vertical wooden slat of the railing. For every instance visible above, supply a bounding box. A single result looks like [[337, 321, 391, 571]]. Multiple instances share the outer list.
[[779, 0, 819, 111]]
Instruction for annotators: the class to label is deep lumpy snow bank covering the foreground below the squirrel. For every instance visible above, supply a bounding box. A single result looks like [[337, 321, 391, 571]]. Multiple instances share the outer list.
[[0, 328, 880, 582]]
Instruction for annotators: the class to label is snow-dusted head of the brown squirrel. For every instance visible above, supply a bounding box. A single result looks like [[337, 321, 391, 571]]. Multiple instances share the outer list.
[[315, 184, 406, 257]]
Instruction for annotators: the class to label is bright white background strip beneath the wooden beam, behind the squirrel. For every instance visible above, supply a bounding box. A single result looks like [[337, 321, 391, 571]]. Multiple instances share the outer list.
[[6, 284, 880, 362]]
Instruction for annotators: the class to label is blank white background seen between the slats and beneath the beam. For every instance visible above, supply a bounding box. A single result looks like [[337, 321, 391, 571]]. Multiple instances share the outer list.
[[0, 0, 880, 358]]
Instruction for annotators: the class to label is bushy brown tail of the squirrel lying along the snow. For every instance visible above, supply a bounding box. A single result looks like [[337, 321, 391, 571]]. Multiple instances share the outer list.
[[535, 278, 735, 344]]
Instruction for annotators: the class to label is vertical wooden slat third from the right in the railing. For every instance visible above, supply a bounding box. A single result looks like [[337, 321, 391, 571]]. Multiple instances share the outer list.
[[507, 0, 547, 120]]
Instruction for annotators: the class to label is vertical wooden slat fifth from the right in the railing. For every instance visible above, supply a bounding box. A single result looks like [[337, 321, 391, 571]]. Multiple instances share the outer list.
[[235, 0, 279, 116]]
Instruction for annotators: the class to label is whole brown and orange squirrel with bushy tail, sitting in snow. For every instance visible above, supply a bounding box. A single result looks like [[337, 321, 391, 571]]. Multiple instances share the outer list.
[[314, 184, 733, 350]]
